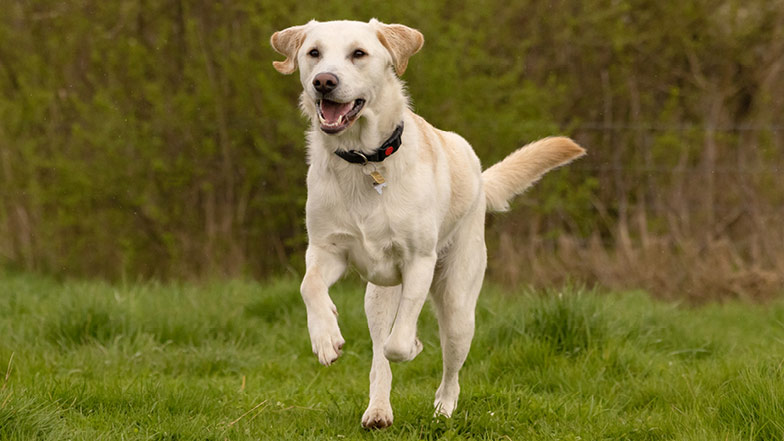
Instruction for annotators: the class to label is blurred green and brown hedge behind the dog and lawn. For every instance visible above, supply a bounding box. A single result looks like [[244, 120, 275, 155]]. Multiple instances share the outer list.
[[0, 0, 784, 300]]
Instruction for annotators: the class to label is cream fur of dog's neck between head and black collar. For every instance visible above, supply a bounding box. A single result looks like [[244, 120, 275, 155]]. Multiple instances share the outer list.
[[308, 78, 408, 156]]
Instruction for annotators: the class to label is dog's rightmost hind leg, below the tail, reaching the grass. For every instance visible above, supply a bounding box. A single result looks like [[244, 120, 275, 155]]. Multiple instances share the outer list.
[[432, 213, 487, 417]]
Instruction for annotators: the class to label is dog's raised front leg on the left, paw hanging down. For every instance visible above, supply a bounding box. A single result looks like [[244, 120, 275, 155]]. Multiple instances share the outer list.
[[300, 245, 347, 366]]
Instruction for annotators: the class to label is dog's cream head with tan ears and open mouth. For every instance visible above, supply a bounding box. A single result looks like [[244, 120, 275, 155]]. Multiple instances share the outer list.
[[270, 19, 424, 134]]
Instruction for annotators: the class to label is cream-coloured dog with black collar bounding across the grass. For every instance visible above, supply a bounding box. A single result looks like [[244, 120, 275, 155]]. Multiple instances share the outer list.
[[270, 19, 585, 428]]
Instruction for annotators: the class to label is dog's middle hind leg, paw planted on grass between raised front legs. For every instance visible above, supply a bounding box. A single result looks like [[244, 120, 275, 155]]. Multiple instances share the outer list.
[[362, 283, 401, 428]]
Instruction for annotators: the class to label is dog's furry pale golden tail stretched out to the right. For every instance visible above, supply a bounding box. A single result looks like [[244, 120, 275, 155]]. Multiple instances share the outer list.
[[482, 136, 585, 211]]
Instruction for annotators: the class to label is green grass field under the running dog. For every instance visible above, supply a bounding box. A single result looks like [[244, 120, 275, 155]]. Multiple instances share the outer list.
[[0, 272, 784, 441]]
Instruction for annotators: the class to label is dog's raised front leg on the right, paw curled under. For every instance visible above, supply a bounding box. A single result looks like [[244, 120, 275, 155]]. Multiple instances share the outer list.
[[384, 251, 436, 362]]
